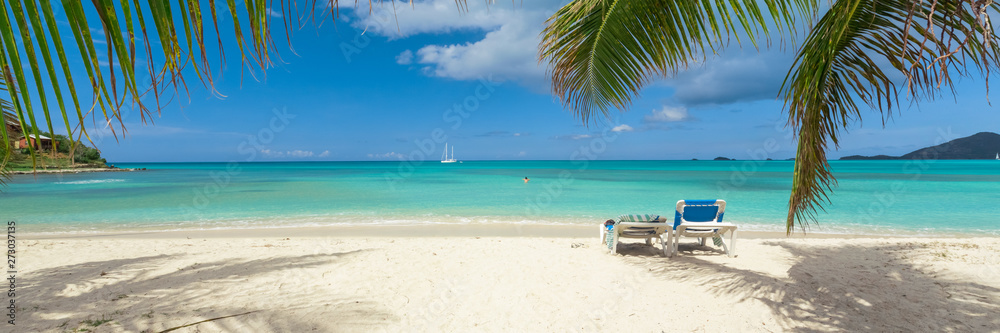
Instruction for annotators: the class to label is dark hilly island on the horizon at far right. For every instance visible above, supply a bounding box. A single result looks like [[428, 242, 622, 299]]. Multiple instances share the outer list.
[[840, 132, 1000, 161]]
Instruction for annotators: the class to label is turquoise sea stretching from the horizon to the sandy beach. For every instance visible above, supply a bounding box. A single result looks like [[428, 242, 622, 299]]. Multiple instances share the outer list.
[[0, 160, 1000, 235]]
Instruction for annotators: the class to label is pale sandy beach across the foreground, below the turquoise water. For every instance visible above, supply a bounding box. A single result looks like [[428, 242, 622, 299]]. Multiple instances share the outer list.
[[15, 226, 1000, 332]]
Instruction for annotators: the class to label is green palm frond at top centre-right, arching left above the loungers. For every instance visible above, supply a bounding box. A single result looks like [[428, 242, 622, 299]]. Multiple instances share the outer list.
[[539, 0, 818, 123]]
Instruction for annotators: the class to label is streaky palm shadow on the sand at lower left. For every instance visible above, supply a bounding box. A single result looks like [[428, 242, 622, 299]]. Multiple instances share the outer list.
[[18, 251, 392, 332]]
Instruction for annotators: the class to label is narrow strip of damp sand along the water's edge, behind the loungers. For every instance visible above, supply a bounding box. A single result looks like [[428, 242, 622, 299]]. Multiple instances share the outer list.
[[21, 224, 998, 240]]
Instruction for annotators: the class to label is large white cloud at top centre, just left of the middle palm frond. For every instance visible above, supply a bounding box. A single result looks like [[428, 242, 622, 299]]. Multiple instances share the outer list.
[[354, 0, 566, 90]]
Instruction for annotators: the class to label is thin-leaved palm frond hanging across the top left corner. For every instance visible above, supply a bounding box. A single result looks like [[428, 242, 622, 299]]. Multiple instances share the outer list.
[[0, 0, 448, 179]]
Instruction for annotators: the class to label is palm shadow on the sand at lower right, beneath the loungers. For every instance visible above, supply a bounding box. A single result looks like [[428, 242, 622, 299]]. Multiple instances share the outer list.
[[621, 241, 1000, 332]]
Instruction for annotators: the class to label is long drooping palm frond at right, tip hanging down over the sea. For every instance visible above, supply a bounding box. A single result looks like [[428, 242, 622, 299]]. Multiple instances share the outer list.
[[782, 0, 1000, 234]]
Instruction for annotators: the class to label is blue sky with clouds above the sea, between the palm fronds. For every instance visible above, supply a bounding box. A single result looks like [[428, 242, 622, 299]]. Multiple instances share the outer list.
[[21, 0, 1000, 163]]
